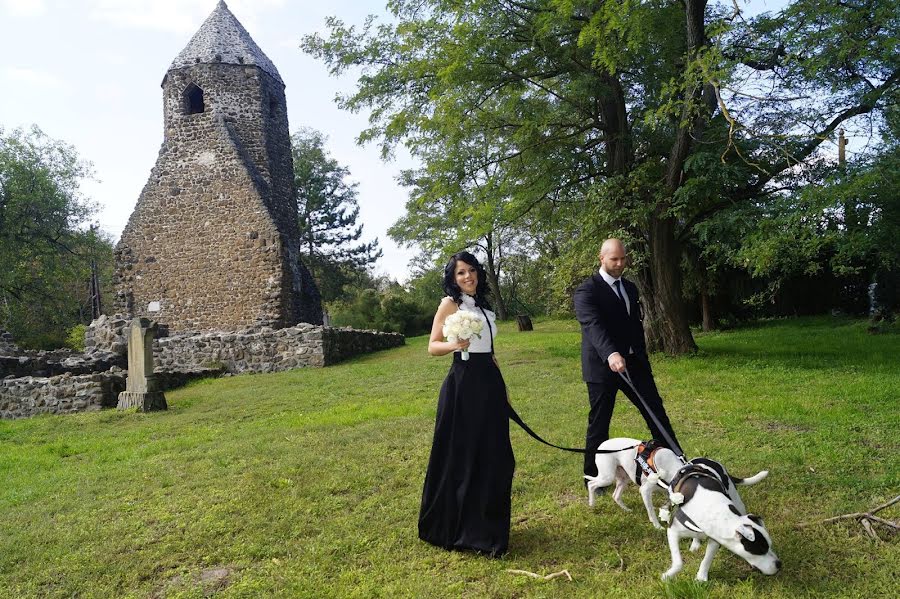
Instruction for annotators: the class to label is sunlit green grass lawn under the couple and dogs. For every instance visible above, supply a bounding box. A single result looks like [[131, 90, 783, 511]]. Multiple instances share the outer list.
[[0, 318, 900, 599]]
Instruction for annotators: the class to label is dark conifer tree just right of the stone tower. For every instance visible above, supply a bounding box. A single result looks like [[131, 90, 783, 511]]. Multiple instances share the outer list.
[[291, 128, 382, 302]]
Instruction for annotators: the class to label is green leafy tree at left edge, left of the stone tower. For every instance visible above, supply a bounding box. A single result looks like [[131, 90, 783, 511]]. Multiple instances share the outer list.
[[0, 127, 112, 348]]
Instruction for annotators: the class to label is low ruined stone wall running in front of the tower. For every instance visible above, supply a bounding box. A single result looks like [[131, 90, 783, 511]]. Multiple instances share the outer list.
[[0, 316, 405, 419]]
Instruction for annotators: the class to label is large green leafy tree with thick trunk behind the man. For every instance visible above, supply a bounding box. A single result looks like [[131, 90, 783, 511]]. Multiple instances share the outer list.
[[304, 0, 900, 353]]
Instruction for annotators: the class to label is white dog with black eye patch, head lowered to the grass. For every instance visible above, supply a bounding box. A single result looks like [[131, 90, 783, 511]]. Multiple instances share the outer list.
[[662, 466, 781, 581]]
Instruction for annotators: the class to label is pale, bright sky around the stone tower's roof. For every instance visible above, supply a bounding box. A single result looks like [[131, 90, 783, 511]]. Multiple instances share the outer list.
[[0, 0, 785, 281]]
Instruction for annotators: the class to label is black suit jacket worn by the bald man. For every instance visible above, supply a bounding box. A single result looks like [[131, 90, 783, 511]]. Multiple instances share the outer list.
[[575, 273, 647, 383]]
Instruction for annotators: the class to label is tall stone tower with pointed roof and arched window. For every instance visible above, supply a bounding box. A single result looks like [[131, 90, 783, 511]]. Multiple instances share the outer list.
[[116, 2, 322, 331]]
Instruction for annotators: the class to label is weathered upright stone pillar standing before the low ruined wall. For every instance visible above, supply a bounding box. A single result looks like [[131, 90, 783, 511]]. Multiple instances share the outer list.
[[116, 318, 169, 412]]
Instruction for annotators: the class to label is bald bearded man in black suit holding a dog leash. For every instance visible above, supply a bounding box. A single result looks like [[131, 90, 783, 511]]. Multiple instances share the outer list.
[[575, 239, 680, 476]]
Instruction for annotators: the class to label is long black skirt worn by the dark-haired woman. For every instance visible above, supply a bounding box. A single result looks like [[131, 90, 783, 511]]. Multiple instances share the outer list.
[[419, 353, 516, 557]]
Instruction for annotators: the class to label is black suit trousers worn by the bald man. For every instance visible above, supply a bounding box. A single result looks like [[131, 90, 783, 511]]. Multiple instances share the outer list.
[[584, 354, 678, 476]]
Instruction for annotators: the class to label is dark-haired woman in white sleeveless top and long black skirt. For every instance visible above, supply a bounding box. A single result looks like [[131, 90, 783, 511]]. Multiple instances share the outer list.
[[419, 252, 515, 557]]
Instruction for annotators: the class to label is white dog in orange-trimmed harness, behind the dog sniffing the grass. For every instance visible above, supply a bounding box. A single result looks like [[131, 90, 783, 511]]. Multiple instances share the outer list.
[[584, 437, 769, 529]]
